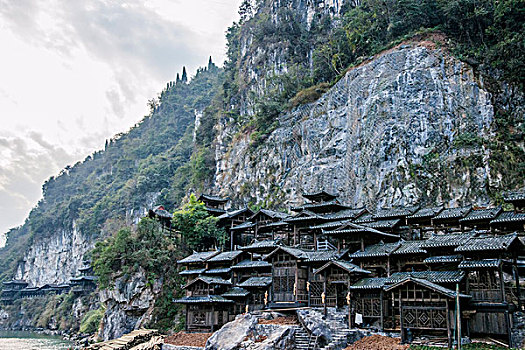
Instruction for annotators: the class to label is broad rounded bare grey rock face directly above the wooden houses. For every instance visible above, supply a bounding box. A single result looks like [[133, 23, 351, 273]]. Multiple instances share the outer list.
[[215, 41, 498, 207]]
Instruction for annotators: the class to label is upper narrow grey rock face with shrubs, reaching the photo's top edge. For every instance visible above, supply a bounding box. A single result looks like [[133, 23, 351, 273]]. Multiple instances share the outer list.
[[231, 0, 344, 116]]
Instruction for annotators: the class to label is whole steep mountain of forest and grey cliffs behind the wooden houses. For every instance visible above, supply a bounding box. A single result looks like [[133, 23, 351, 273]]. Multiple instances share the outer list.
[[0, 0, 525, 338]]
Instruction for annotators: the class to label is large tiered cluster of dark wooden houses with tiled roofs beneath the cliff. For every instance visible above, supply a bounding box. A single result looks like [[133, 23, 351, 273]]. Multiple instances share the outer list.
[[175, 190, 525, 341]]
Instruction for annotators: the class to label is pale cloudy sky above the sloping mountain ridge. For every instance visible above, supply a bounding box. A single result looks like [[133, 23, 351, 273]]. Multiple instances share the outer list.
[[0, 0, 242, 237]]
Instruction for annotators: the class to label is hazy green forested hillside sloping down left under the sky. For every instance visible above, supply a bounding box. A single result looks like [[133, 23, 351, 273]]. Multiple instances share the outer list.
[[0, 59, 221, 280]]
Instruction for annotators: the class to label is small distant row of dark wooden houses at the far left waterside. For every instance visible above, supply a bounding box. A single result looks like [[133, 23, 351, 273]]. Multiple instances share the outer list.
[[0, 264, 97, 305]]
